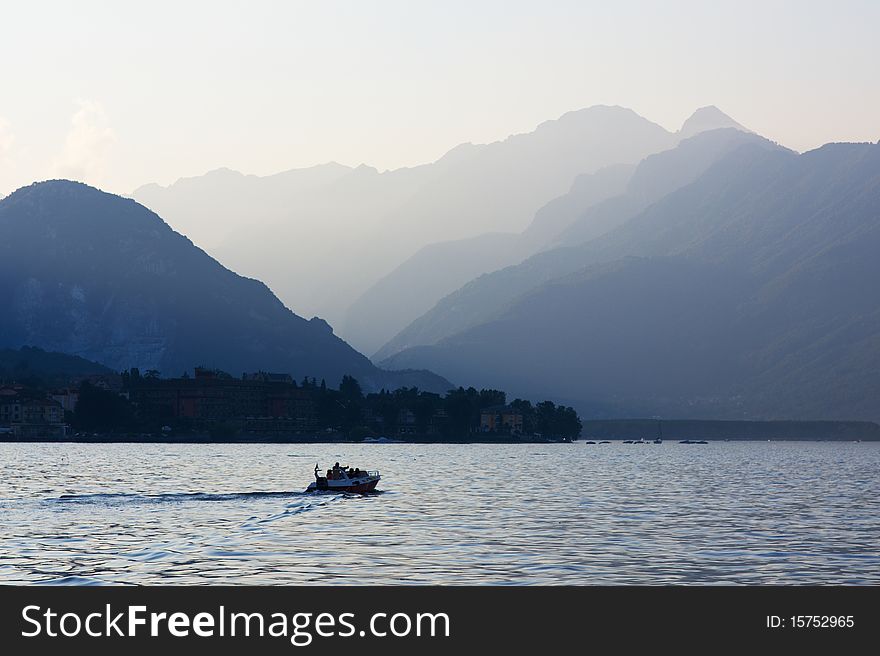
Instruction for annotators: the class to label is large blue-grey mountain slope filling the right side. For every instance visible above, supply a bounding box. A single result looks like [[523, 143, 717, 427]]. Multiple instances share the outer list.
[[386, 144, 880, 420]]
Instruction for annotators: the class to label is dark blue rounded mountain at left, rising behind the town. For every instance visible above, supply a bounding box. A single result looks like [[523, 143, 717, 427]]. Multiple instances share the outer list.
[[0, 181, 449, 391]]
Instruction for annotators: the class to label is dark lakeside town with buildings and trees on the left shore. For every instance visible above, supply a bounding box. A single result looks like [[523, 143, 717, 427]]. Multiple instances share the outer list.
[[0, 367, 582, 441]]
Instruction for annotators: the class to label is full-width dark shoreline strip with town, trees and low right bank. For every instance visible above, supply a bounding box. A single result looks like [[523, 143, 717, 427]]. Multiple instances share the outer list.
[[6, 347, 880, 444]]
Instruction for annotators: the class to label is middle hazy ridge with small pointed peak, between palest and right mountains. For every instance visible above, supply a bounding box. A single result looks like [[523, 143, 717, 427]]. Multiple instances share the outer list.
[[343, 107, 748, 360]]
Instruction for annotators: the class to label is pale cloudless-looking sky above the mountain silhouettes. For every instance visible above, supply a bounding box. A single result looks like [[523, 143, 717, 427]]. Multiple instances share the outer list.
[[0, 0, 880, 196]]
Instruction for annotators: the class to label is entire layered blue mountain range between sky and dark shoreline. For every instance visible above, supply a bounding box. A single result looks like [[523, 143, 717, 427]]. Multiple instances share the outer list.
[[0, 102, 880, 421]]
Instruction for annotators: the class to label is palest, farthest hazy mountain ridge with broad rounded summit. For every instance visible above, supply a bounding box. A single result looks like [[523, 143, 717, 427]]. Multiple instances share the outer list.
[[134, 106, 676, 346]]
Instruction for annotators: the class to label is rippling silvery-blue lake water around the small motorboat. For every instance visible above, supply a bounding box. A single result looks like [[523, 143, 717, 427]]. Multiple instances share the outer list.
[[0, 442, 880, 585]]
